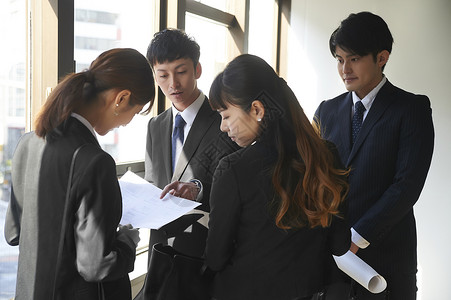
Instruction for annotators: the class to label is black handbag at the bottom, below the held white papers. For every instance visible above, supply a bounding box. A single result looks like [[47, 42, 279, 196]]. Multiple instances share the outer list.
[[141, 243, 213, 300]]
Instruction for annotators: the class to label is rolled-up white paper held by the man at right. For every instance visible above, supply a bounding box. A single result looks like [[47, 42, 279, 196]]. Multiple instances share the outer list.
[[333, 251, 387, 294]]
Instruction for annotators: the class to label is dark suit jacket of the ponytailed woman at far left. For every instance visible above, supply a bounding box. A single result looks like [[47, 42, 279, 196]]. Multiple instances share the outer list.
[[5, 118, 136, 300]]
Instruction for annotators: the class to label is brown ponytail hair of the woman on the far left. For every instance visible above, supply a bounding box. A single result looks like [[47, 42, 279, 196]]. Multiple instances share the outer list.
[[35, 48, 155, 137]]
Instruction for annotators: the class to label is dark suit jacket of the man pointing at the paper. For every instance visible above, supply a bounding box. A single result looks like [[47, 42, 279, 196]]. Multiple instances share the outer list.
[[145, 97, 238, 257]]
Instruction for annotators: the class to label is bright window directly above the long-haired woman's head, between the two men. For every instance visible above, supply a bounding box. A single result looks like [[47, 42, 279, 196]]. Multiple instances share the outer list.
[[185, 0, 278, 95]]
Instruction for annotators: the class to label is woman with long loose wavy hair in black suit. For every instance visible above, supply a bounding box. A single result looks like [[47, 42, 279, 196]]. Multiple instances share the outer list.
[[206, 54, 350, 300]]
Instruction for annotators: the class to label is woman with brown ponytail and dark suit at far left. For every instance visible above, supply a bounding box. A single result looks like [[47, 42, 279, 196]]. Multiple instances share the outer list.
[[5, 48, 155, 300]]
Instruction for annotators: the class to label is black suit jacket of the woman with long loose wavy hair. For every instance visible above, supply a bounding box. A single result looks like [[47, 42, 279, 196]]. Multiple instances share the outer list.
[[206, 141, 350, 300]]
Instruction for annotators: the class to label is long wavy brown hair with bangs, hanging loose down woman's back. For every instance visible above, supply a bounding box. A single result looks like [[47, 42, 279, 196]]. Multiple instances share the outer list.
[[209, 54, 348, 229]]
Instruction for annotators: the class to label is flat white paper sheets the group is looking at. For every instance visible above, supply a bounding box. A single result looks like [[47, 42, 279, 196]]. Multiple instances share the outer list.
[[119, 171, 201, 229]]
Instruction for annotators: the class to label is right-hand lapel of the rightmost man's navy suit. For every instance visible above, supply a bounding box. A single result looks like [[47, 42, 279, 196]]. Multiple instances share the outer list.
[[346, 80, 393, 166]]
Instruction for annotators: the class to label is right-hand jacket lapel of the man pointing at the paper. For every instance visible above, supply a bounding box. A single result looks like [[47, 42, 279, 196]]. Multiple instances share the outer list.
[[171, 97, 216, 182]]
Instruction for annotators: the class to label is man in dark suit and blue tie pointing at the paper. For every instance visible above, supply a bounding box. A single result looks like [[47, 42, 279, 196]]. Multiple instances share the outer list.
[[137, 29, 238, 299]]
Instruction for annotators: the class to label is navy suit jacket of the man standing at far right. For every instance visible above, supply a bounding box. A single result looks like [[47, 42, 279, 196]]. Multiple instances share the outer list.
[[315, 81, 434, 287]]
